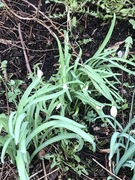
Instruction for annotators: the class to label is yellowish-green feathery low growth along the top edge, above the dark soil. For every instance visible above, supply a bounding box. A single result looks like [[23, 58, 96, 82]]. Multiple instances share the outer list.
[[48, 0, 135, 19]]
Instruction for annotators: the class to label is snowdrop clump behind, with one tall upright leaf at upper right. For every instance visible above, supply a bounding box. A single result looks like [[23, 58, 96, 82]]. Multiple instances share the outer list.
[[55, 16, 135, 119]]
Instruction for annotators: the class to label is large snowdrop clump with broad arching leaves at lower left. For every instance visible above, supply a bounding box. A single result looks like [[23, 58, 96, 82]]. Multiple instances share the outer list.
[[0, 68, 95, 180]]
